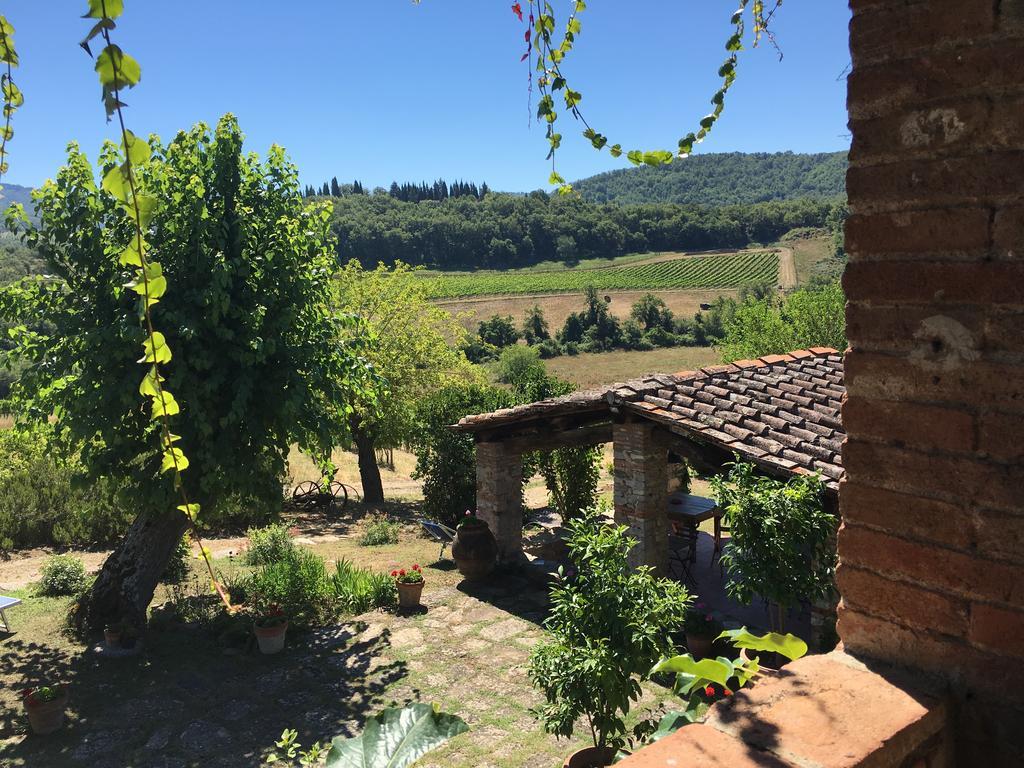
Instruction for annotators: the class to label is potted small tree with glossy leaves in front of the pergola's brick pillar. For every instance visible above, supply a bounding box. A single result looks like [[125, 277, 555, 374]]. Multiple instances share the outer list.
[[529, 510, 689, 768]]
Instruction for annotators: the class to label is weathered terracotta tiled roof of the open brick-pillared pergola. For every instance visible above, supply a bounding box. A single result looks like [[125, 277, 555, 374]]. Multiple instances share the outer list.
[[455, 347, 846, 490]]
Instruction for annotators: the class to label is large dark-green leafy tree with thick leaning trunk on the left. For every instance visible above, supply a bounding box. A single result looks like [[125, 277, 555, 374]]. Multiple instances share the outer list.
[[0, 116, 369, 626]]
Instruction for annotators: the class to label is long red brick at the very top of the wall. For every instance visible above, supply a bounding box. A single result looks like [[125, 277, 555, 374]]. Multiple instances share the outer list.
[[850, 0, 995, 67]]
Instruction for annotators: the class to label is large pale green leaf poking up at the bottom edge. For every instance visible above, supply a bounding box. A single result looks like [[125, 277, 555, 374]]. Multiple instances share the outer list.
[[327, 703, 469, 768]]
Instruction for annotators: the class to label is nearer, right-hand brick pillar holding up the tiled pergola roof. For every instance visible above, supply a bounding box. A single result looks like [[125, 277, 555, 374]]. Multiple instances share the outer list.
[[613, 422, 669, 574]]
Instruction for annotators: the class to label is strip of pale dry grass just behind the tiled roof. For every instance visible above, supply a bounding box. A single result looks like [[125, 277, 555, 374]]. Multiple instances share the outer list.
[[546, 347, 722, 388]]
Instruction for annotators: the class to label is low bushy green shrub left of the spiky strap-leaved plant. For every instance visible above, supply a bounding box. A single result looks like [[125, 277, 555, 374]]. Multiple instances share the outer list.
[[231, 548, 339, 627]]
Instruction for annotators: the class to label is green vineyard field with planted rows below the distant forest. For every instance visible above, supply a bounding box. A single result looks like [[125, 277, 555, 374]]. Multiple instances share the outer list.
[[424, 251, 778, 299]]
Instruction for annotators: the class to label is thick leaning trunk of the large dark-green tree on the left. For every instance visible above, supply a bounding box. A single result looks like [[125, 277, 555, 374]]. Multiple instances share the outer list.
[[76, 510, 188, 629]]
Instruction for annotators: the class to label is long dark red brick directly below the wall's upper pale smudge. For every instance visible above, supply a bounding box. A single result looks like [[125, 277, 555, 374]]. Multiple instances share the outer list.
[[846, 152, 1024, 213]]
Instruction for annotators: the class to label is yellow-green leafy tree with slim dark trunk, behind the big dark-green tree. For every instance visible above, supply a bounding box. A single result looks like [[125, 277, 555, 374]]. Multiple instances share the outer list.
[[336, 260, 477, 504]]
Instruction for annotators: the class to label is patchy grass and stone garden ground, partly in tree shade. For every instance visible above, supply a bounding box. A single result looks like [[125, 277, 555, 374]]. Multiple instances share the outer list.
[[0, 520, 688, 768]]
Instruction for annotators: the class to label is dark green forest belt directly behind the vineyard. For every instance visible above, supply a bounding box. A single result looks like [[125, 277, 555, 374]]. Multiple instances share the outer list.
[[332, 189, 844, 269]]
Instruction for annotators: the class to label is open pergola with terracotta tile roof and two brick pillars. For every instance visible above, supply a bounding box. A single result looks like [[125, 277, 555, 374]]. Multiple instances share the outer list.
[[453, 347, 846, 572]]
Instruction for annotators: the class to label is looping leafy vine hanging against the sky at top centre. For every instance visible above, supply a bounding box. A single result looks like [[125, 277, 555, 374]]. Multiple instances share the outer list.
[[512, 0, 782, 195]]
